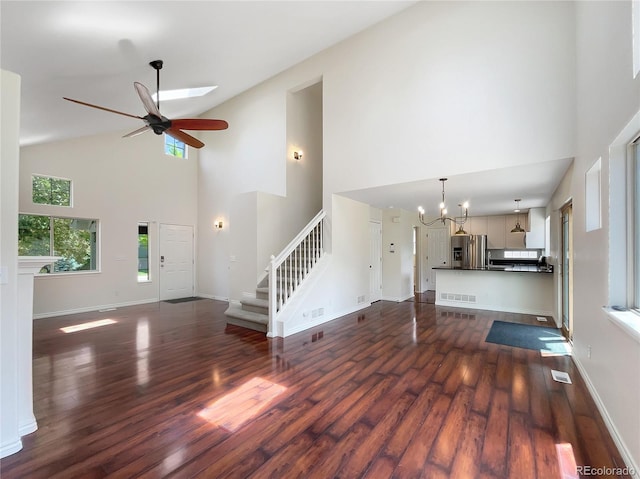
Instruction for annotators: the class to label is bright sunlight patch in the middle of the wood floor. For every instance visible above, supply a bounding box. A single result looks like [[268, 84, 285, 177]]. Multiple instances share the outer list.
[[198, 377, 287, 432]]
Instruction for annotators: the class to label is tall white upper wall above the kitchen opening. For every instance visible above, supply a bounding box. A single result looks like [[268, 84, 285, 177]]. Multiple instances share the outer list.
[[320, 2, 575, 192]]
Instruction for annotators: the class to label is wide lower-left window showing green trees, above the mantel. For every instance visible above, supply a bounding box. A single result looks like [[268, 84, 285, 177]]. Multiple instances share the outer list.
[[18, 215, 98, 273]]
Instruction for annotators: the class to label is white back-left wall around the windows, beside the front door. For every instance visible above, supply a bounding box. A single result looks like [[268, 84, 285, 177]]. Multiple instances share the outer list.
[[20, 130, 198, 317]]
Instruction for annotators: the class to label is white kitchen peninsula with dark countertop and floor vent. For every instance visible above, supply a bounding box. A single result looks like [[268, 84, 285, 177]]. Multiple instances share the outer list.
[[434, 265, 555, 317]]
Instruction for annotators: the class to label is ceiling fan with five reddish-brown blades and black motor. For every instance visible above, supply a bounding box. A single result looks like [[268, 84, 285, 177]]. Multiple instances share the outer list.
[[63, 60, 229, 148]]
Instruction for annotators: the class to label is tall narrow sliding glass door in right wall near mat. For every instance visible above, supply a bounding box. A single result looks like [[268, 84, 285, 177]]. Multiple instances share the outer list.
[[560, 202, 573, 341]]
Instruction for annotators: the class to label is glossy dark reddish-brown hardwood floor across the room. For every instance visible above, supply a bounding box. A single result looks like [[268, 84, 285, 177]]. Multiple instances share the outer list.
[[0, 298, 624, 479]]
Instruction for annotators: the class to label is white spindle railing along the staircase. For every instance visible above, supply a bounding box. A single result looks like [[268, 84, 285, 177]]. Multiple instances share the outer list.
[[268, 211, 326, 334]]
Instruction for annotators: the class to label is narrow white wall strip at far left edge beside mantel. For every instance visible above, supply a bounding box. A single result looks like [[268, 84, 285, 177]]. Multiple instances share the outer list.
[[0, 70, 24, 457]]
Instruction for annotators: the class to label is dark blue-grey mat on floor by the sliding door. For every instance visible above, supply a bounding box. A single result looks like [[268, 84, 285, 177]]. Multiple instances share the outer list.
[[485, 321, 571, 355]]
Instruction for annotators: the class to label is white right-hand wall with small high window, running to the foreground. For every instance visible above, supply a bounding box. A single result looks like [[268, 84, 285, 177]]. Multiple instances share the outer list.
[[564, 1, 640, 470]]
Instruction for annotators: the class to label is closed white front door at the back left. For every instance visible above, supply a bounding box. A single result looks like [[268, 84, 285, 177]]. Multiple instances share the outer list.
[[159, 224, 194, 301]]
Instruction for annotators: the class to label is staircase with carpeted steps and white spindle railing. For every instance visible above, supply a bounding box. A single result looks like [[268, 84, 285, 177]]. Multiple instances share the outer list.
[[224, 211, 326, 335]]
